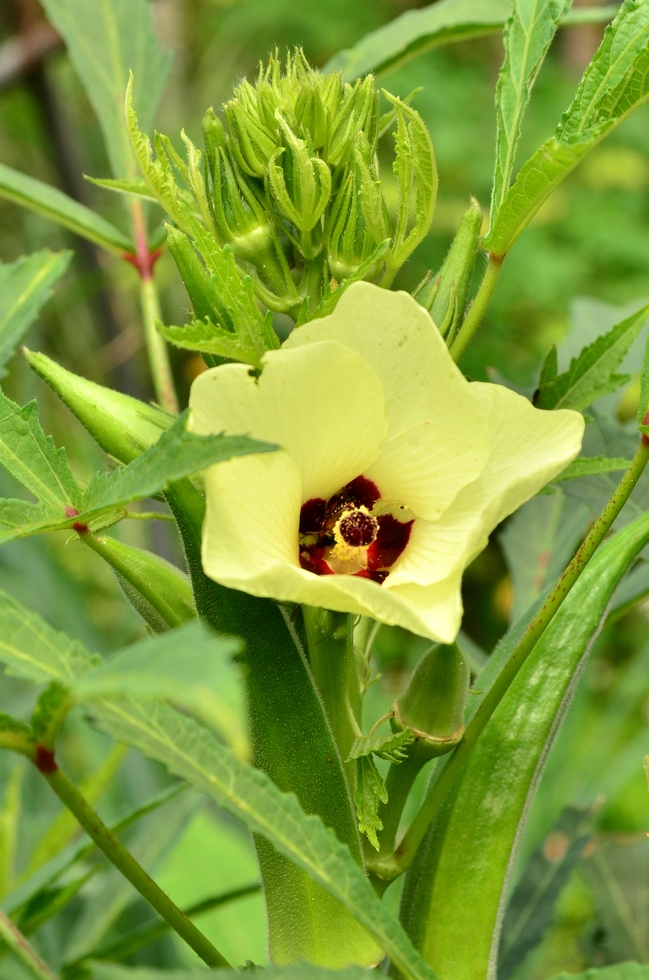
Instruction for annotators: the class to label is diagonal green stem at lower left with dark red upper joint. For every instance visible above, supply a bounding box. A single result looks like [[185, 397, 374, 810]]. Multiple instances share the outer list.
[[39, 756, 230, 967]]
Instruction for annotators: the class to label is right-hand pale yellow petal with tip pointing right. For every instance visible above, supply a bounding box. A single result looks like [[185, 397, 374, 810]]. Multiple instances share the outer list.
[[389, 382, 584, 586]]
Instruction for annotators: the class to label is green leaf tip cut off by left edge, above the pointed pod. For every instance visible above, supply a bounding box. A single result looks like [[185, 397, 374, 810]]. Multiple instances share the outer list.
[[0, 249, 72, 377]]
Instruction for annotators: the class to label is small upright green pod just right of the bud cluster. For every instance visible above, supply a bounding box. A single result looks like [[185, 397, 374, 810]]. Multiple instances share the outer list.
[[415, 198, 482, 339]]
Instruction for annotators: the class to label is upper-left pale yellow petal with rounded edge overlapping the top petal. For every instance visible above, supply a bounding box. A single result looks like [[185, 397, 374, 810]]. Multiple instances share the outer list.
[[190, 340, 387, 502]]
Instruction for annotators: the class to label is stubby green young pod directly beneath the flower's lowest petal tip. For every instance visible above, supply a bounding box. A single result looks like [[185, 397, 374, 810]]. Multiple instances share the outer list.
[[392, 643, 470, 760]]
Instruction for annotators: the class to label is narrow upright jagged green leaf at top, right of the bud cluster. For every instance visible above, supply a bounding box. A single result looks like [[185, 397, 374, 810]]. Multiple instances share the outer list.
[[491, 0, 572, 224]]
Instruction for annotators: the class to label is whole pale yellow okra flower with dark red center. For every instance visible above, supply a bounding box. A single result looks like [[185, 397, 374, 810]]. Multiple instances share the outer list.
[[190, 282, 584, 643]]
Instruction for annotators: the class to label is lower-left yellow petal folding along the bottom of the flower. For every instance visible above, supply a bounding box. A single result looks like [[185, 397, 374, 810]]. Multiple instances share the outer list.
[[203, 452, 462, 643]]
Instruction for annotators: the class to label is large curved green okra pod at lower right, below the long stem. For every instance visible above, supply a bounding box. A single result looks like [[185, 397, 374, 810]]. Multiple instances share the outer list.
[[403, 514, 649, 976]]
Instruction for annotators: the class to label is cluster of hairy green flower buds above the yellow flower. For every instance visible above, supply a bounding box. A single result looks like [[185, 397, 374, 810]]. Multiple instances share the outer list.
[[197, 50, 436, 319]]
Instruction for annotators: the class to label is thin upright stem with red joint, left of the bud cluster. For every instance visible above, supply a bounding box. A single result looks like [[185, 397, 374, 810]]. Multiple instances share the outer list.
[[131, 201, 178, 415]]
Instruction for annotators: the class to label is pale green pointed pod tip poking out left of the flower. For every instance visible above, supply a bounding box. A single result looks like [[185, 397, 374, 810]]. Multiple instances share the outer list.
[[25, 351, 174, 463]]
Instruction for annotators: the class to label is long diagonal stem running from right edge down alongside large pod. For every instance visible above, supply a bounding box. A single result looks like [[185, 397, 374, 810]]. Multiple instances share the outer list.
[[372, 435, 649, 879]]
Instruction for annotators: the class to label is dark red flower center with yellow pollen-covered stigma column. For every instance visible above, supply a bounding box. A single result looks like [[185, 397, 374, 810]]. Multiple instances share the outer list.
[[299, 476, 414, 584]]
